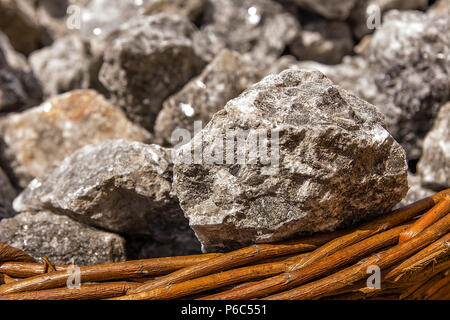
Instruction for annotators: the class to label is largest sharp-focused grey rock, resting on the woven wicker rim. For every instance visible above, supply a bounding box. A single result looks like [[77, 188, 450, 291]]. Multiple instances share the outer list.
[[174, 69, 408, 251]]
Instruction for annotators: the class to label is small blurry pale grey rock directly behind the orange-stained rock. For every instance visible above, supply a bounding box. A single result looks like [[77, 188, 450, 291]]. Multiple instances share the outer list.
[[30, 35, 92, 97]]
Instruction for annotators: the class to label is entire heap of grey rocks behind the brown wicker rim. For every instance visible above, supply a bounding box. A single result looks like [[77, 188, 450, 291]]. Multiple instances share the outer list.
[[0, 0, 450, 265]]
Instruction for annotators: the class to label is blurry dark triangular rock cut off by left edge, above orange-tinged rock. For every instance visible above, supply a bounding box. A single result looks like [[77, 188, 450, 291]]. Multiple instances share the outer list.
[[0, 32, 42, 112]]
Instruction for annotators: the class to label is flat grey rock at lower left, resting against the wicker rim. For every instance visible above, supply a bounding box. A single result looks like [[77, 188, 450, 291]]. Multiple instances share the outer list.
[[0, 211, 126, 266]]
